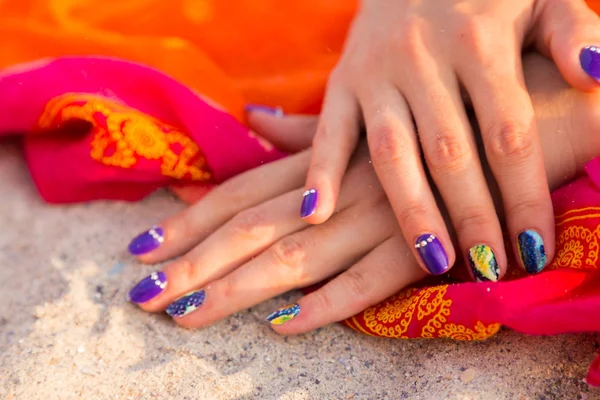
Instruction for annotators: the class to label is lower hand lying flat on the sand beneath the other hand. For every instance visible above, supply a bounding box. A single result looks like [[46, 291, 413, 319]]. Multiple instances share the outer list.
[[125, 131, 425, 333]]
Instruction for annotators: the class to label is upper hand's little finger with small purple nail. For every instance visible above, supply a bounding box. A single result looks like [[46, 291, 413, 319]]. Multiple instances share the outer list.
[[300, 90, 359, 224]]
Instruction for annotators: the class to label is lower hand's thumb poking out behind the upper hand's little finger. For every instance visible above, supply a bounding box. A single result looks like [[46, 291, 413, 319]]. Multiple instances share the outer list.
[[248, 110, 319, 153]]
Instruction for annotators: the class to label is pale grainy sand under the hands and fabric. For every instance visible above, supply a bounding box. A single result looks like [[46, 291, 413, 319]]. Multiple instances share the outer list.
[[0, 144, 600, 400]]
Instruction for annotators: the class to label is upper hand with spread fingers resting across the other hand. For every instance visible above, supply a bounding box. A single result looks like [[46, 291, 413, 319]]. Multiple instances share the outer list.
[[301, 0, 600, 280]]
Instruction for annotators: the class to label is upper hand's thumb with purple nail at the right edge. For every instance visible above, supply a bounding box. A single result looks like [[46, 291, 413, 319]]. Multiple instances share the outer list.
[[537, 0, 600, 91]]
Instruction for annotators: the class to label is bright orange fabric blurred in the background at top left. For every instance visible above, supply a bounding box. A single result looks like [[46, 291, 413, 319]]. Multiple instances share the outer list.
[[0, 0, 355, 120]]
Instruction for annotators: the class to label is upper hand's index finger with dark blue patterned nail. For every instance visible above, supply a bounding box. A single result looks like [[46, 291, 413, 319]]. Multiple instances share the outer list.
[[459, 40, 554, 273]]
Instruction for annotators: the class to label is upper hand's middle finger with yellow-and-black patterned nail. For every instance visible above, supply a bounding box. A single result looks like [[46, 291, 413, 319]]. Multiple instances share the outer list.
[[404, 60, 507, 281]]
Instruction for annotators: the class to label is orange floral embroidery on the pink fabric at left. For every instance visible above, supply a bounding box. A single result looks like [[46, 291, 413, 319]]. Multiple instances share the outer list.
[[38, 93, 211, 181]]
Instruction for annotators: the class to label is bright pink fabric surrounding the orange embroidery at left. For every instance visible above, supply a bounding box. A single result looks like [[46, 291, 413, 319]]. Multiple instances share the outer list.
[[0, 58, 284, 203]]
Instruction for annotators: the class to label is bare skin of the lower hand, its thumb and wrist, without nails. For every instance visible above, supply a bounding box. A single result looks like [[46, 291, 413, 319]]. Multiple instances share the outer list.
[[130, 55, 600, 334]]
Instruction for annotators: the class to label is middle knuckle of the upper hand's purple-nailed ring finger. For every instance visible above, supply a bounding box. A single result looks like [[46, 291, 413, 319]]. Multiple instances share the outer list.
[[369, 124, 415, 169]]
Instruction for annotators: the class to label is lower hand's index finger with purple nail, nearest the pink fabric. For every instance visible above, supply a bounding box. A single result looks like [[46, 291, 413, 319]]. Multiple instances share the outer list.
[[129, 151, 310, 263]]
